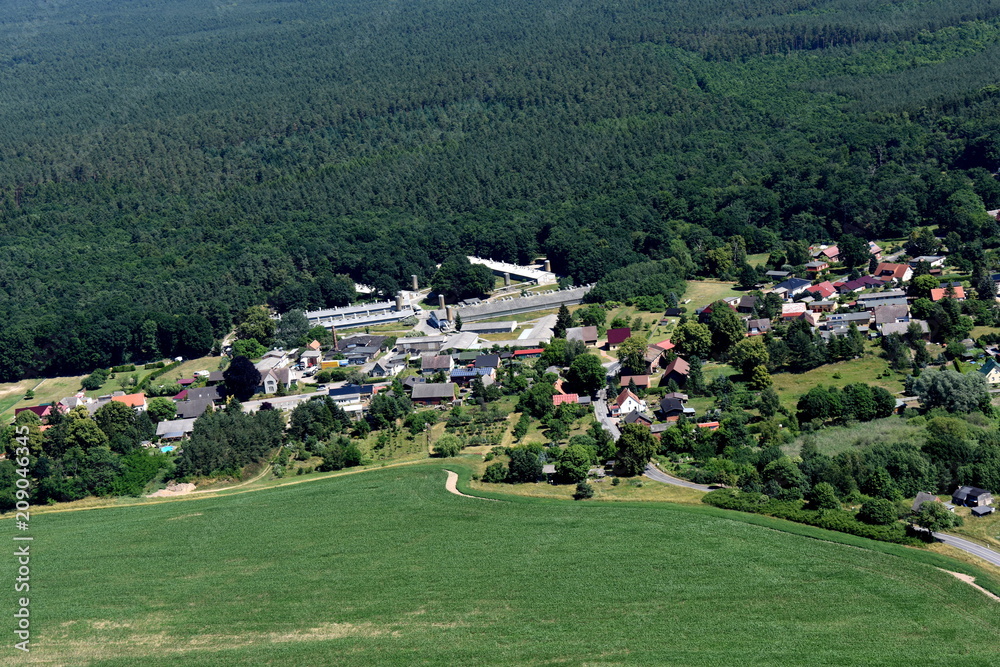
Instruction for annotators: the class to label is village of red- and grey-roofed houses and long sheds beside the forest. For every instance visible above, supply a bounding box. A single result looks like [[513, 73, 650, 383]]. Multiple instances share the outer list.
[[7, 243, 1000, 536]]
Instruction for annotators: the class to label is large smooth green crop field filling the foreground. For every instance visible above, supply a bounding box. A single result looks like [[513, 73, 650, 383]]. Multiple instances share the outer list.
[[7, 461, 1000, 667]]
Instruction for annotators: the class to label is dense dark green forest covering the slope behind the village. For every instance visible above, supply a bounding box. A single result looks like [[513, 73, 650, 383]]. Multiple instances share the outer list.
[[0, 0, 1000, 380]]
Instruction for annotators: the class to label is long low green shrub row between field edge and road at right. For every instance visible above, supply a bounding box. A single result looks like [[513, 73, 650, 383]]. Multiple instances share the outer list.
[[702, 489, 920, 545]]
